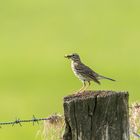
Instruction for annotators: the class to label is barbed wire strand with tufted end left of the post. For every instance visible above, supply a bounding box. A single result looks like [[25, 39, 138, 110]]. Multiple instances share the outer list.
[[0, 114, 62, 128]]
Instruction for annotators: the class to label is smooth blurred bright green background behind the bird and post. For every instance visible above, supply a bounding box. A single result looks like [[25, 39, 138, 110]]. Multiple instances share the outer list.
[[0, 0, 140, 140]]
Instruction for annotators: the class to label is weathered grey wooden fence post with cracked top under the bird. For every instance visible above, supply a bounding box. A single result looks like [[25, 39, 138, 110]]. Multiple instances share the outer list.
[[63, 91, 129, 140]]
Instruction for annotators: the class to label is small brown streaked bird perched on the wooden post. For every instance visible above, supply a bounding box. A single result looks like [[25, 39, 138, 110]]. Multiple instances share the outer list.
[[65, 53, 115, 92]]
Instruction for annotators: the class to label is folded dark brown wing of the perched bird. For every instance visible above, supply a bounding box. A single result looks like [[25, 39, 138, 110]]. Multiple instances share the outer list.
[[75, 63, 100, 84]]
